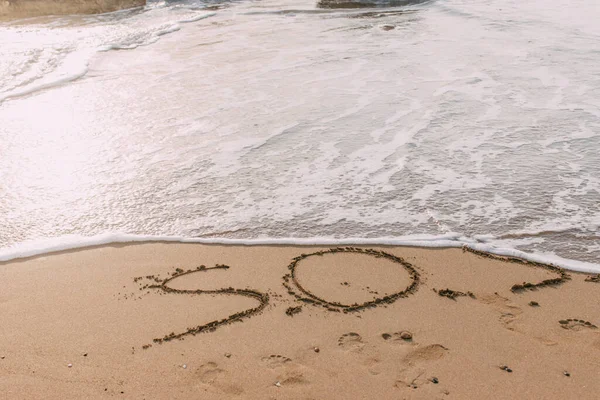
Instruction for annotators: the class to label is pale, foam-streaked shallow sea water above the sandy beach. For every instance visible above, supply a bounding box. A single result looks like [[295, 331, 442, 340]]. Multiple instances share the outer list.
[[0, 0, 600, 269]]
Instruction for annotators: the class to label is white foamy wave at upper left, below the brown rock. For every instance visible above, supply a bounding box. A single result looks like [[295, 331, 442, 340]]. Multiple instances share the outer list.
[[0, 4, 216, 104]]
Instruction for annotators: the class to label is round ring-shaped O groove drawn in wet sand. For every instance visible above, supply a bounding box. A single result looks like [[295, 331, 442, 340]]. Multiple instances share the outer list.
[[283, 247, 420, 313]]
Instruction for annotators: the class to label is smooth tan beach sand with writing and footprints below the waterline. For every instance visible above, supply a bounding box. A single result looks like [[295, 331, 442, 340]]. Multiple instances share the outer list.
[[0, 243, 600, 399]]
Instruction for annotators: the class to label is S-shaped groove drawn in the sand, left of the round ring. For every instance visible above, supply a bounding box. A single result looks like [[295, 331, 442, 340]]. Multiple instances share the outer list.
[[134, 264, 269, 349]]
